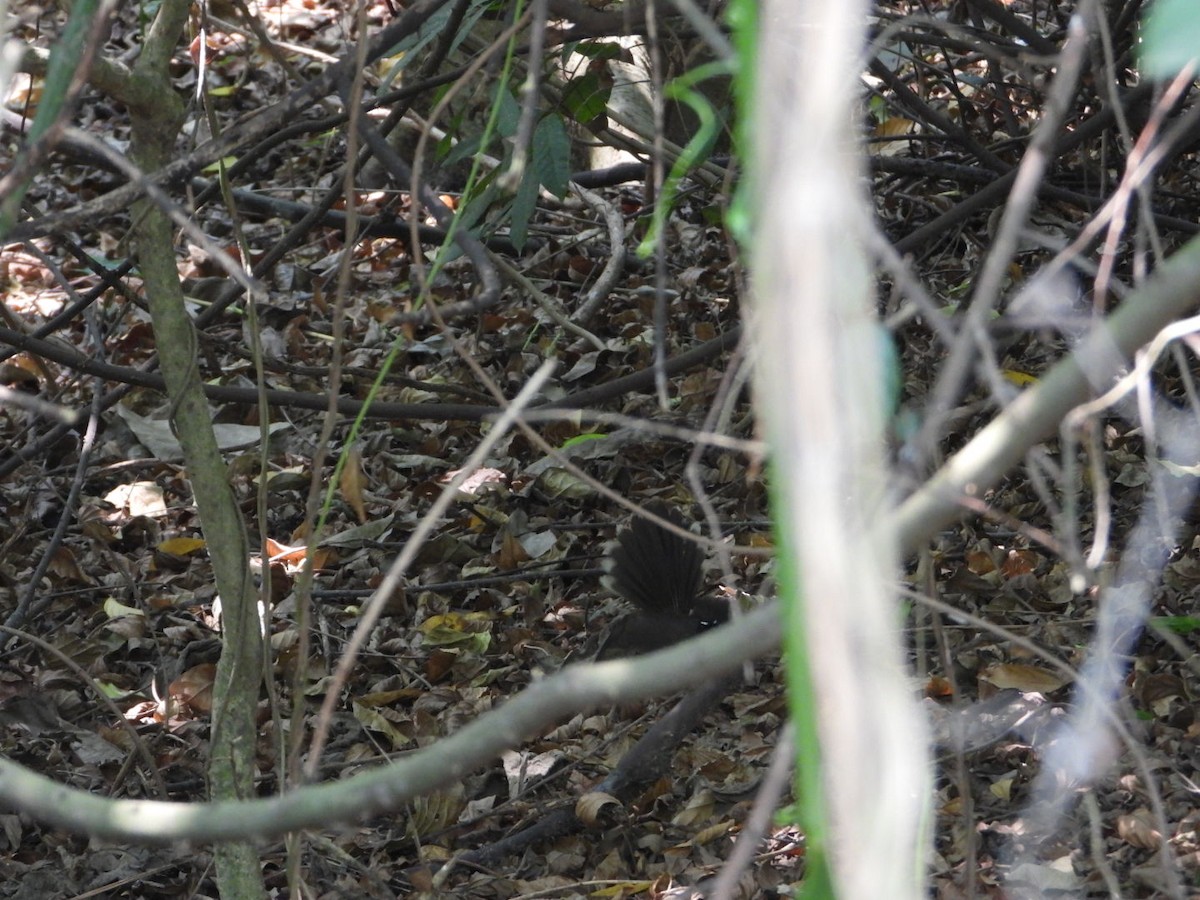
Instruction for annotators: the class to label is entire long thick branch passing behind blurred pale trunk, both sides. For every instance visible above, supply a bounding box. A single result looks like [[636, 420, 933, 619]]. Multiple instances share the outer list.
[[0, 214, 1200, 844]]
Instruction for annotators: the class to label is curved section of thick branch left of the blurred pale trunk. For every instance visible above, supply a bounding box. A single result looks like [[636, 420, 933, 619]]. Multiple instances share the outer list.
[[0, 607, 779, 844]]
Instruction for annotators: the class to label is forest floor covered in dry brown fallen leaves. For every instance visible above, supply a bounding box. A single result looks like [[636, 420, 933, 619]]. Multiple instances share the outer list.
[[0, 2, 1200, 898]]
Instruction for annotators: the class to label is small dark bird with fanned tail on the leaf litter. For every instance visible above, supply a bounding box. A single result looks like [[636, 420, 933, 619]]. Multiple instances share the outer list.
[[596, 502, 730, 659]]
